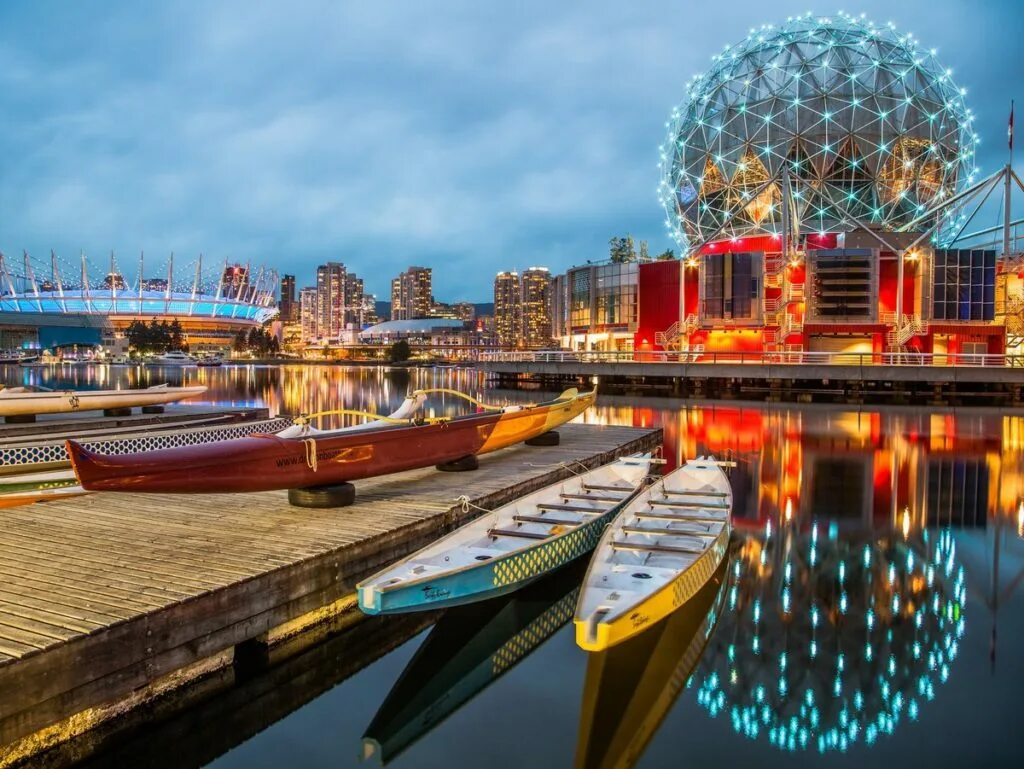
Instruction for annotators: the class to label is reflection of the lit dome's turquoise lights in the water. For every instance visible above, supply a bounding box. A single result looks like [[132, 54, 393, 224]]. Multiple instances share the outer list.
[[696, 523, 967, 753]]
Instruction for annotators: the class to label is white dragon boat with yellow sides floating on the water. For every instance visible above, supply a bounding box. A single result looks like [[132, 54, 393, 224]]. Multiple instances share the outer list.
[[574, 457, 732, 651]]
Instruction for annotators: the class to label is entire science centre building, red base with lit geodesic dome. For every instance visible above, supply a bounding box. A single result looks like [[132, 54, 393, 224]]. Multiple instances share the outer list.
[[555, 14, 1024, 359]]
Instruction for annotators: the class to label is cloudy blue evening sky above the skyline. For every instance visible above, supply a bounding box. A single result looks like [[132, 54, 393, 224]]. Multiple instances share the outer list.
[[0, 0, 1024, 301]]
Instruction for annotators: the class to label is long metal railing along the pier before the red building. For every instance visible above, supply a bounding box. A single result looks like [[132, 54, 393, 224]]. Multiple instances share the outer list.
[[479, 350, 1024, 369]]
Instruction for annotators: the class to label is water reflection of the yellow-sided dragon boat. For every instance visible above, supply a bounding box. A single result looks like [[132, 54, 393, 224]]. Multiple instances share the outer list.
[[574, 561, 727, 769]]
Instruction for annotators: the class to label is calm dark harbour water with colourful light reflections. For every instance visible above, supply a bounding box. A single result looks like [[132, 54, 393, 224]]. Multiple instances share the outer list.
[[6, 367, 1024, 768]]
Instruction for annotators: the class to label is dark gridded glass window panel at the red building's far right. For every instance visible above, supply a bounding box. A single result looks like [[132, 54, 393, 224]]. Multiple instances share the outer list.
[[932, 249, 995, 321]]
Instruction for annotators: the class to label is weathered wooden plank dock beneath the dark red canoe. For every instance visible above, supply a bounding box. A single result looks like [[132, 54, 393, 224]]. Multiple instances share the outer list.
[[0, 425, 662, 765]]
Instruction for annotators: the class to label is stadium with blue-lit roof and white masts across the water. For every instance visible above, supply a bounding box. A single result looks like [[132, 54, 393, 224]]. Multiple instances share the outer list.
[[0, 254, 278, 350]]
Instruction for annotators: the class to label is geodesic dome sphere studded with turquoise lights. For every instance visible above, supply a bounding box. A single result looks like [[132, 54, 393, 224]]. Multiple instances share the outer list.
[[659, 14, 977, 250]]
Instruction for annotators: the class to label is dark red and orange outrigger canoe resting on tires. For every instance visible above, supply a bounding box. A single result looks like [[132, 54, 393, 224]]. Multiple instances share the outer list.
[[68, 389, 595, 494]]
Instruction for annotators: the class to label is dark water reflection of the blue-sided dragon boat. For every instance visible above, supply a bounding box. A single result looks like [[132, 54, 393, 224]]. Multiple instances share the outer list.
[[362, 561, 586, 765]]
